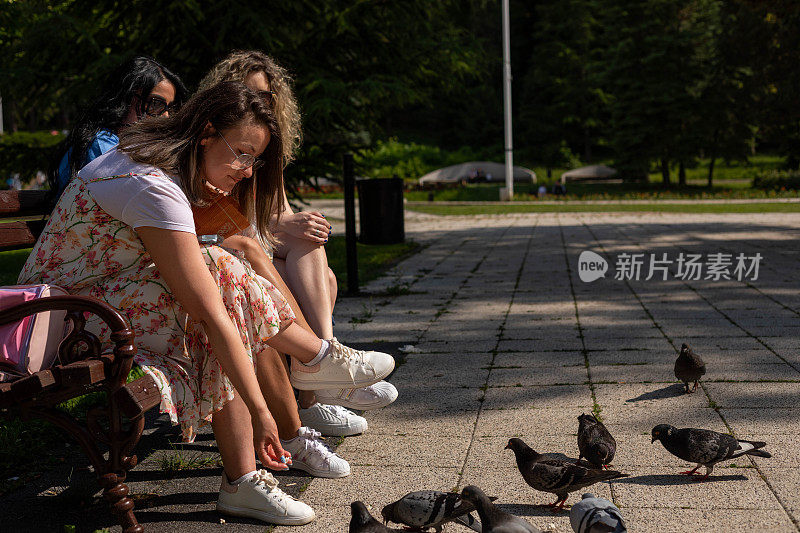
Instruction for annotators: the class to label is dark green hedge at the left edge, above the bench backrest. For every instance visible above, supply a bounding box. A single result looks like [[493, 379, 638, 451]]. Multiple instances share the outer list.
[[0, 131, 64, 188]]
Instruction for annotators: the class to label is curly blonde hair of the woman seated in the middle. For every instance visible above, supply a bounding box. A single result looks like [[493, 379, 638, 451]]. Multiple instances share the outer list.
[[198, 50, 302, 165]]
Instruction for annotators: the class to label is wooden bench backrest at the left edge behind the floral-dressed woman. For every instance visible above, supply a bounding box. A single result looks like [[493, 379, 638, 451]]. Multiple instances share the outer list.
[[0, 191, 52, 251]]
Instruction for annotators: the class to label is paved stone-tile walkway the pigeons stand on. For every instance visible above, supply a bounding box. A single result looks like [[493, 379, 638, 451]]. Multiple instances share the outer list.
[[288, 213, 800, 533]]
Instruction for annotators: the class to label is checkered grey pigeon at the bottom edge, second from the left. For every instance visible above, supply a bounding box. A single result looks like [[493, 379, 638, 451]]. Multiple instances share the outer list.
[[381, 490, 488, 532]]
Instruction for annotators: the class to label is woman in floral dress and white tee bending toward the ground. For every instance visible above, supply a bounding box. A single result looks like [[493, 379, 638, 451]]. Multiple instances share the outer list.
[[19, 83, 394, 524]]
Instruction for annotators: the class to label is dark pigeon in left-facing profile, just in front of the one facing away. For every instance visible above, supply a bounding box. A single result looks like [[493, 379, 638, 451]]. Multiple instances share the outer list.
[[506, 438, 628, 510]]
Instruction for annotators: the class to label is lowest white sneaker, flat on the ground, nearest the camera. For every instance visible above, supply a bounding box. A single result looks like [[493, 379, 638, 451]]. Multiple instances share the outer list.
[[217, 470, 316, 526]]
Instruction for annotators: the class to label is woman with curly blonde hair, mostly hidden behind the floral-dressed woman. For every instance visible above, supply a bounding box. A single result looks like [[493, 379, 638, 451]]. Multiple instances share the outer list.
[[200, 50, 397, 435]]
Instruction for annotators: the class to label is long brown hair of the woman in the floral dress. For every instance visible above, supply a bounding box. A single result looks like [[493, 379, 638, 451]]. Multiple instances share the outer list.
[[119, 82, 283, 241]]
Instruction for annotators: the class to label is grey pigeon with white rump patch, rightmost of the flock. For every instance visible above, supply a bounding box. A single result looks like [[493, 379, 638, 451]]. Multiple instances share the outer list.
[[651, 424, 772, 480]]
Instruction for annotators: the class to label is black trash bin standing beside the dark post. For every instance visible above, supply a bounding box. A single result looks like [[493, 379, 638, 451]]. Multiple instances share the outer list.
[[356, 178, 406, 244]]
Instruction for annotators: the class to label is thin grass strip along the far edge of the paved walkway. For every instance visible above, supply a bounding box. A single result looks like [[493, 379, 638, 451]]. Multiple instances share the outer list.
[[406, 200, 800, 215]]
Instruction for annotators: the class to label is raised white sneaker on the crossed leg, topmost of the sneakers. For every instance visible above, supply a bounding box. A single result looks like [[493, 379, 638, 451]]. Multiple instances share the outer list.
[[291, 337, 394, 390]]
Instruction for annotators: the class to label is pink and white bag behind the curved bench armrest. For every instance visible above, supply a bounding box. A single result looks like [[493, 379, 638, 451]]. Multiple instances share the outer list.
[[0, 285, 67, 381]]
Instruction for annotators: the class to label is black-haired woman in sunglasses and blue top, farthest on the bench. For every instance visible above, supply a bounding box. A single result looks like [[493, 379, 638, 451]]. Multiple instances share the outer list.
[[48, 56, 188, 196]]
